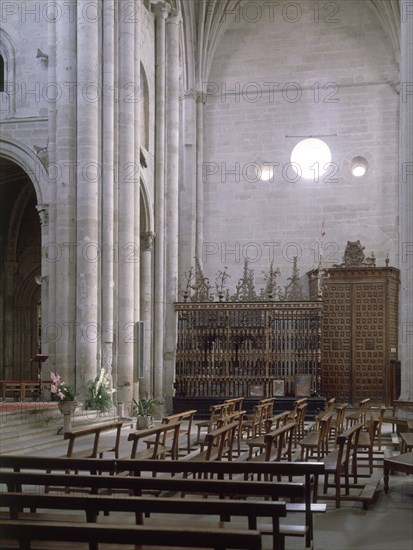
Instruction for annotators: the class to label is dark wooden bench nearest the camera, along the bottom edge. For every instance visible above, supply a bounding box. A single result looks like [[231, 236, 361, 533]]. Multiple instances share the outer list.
[[0, 520, 262, 550]]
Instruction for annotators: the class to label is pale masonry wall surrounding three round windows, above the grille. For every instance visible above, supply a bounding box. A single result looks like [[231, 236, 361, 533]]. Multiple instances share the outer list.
[[202, 0, 399, 298]]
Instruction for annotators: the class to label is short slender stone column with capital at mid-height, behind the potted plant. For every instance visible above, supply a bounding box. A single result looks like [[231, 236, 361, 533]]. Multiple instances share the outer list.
[[139, 231, 156, 395]]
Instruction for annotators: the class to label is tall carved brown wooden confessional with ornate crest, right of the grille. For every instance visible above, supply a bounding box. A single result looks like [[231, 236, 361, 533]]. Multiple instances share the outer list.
[[308, 241, 400, 404]]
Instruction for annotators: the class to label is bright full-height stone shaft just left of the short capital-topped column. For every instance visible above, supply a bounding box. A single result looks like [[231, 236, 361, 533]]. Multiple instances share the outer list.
[[117, 2, 139, 402]]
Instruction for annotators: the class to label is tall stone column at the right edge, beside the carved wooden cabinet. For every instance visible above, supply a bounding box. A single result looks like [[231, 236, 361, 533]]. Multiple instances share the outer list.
[[399, 0, 413, 401]]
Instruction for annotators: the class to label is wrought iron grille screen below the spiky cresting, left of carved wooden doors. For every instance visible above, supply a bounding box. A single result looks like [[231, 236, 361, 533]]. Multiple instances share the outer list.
[[175, 302, 322, 397]]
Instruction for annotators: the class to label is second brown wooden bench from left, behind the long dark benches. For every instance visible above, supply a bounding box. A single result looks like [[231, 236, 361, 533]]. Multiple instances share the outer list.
[[128, 421, 181, 460]]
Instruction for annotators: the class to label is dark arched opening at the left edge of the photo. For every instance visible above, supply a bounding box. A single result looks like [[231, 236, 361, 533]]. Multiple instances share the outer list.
[[0, 158, 41, 380]]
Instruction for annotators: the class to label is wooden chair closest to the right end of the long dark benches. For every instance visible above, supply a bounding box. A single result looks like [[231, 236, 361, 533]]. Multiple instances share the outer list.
[[322, 422, 362, 508]]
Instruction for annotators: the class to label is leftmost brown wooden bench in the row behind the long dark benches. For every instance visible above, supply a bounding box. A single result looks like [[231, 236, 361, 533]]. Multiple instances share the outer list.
[[64, 420, 123, 458]]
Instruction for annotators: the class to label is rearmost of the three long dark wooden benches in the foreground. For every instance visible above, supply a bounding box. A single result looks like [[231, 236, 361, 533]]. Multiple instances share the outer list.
[[0, 455, 325, 547]]
